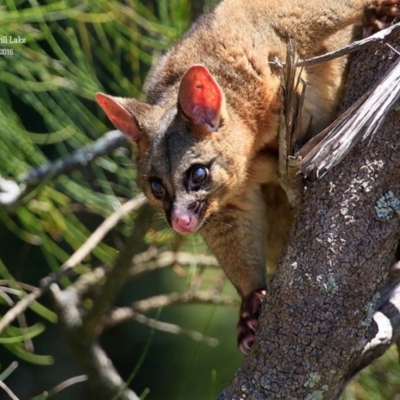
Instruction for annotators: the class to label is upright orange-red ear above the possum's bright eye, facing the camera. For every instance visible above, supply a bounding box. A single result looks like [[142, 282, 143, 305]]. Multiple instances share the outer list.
[[178, 65, 225, 131]]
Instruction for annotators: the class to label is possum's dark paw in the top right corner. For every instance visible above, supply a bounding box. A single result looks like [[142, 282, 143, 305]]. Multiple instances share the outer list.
[[363, 0, 400, 37]]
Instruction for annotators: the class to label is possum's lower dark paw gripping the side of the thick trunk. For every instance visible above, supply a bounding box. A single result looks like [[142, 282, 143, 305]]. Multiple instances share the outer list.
[[237, 289, 266, 354]]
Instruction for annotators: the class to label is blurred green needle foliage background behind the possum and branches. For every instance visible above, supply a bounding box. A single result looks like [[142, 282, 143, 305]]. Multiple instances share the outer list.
[[0, 0, 400, 400]]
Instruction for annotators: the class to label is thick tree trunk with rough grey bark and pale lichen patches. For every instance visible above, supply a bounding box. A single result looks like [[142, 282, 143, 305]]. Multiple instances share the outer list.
[[219, 35, 400, 400]]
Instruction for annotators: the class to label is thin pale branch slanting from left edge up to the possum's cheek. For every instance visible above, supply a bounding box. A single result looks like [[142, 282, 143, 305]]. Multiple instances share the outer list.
[[0, 195, 146, 333]]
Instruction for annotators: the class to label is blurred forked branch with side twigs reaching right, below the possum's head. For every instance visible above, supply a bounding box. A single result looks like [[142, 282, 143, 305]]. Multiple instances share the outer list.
[[50, 209, 225, 400]]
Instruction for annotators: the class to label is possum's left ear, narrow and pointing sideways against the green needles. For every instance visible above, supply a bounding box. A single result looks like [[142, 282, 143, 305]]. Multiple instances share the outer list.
[[96, 93, 146, 142]]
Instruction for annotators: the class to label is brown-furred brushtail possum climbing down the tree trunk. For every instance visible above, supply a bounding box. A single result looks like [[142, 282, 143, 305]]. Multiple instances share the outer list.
[[96, 0, 400, 353]]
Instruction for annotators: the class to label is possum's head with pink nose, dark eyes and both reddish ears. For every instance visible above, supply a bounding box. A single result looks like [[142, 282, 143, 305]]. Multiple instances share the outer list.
[[96, 65, 252, 234]]
